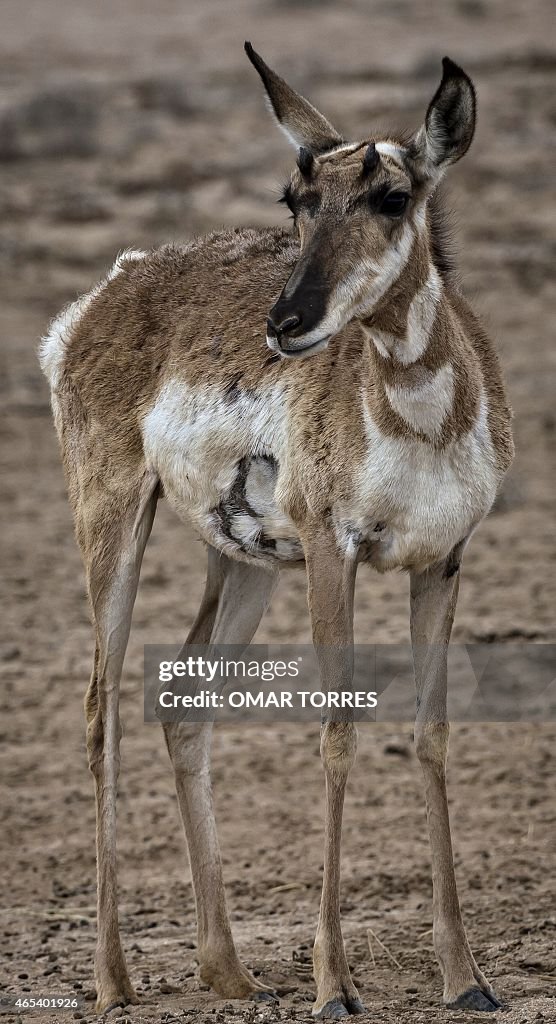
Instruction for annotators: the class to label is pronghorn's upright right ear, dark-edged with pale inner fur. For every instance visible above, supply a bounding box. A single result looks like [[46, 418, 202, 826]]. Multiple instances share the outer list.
[[413, 57, 476, 174]]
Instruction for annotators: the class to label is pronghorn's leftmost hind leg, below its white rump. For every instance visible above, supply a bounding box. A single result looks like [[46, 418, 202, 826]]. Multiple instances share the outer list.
[[81, 473, 158, 1012]]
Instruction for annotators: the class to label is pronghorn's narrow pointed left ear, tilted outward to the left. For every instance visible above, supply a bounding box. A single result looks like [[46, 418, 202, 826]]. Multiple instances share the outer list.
[[245, 43, 343, 156]]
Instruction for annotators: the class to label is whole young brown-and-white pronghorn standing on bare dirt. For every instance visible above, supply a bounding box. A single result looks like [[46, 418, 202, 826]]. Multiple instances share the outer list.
[[41, 43, 513, 1018]]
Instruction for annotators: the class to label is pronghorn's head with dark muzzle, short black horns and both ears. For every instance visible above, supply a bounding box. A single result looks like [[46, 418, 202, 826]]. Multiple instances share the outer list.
[[245, 43, 475, 357]]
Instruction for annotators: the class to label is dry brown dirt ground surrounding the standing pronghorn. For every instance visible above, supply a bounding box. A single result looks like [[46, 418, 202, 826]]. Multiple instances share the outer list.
[[0, 0, 556, 1024]]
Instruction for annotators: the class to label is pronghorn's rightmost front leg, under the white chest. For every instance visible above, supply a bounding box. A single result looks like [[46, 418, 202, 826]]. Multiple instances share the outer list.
[[411, 542, 500, 1011]]
